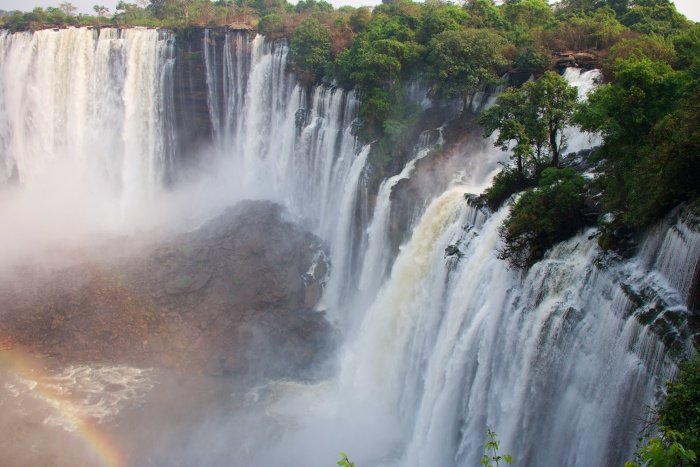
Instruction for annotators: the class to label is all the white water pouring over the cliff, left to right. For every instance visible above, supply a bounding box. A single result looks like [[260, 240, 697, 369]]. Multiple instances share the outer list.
[[0, 29, 700, 466]]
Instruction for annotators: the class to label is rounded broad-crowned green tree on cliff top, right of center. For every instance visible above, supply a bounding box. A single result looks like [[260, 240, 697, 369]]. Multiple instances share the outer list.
[[426, 28, 508, 110]]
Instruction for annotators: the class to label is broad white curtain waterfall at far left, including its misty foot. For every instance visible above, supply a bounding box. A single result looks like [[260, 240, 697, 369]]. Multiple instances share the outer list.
[[0, 29, 176, 266]]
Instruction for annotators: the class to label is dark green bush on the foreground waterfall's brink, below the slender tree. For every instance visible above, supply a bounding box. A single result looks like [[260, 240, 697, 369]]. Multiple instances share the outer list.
[[498, 167, 588, 269]]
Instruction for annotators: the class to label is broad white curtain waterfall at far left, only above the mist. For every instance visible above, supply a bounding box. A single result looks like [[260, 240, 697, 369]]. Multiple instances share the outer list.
[[0, 28, 174, 197]]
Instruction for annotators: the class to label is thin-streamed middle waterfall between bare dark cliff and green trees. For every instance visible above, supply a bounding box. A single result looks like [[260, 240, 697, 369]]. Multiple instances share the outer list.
[[204, 32, 370, 311]]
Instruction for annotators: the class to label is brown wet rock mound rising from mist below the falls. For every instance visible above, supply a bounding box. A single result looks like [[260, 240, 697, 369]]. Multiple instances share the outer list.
[[0, 201, 332, 384]]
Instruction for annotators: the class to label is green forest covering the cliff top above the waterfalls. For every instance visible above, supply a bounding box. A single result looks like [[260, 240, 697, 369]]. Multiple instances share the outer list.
[[0, 0, 700, 465]]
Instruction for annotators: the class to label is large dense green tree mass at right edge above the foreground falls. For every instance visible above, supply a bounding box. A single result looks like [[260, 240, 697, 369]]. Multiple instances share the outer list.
[[575, 56, 700, 227]]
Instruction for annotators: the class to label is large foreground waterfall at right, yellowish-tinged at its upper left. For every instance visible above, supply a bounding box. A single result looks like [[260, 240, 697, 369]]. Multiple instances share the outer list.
[[250, 188, 690, 466]]
